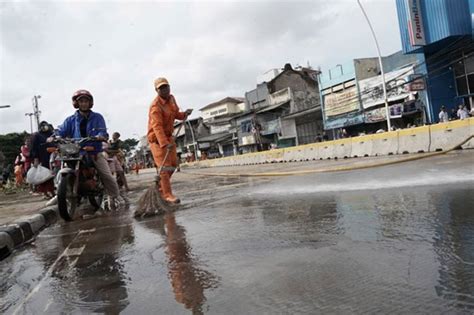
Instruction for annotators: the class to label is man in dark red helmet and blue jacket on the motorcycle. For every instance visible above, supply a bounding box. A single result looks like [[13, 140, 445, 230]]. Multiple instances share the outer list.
[[56, 90, 119, 210]]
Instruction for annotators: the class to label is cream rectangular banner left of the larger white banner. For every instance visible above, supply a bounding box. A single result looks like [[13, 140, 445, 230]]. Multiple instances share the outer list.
[[323, 86, 360, 117]]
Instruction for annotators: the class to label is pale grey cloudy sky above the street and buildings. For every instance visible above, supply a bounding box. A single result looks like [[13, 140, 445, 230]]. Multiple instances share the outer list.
[[0, 0, 401, 138]]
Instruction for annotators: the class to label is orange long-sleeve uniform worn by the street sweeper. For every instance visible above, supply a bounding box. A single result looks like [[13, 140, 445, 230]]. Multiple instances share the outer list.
[[147, 95, 186, 171]]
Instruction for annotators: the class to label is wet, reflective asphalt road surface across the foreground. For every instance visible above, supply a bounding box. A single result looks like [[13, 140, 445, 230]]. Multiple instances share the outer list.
[[0, 152, 474, 314]]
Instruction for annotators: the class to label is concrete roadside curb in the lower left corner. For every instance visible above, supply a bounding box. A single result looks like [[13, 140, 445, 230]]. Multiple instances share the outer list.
[[0, 207, 58, 260]]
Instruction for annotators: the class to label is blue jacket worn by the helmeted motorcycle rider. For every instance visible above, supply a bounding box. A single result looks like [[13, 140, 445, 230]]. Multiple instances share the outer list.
[[55, 110, 107, 153]]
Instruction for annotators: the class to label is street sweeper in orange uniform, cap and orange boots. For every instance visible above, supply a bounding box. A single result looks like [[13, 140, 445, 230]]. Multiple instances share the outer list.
[[147, 78, 192, 203]]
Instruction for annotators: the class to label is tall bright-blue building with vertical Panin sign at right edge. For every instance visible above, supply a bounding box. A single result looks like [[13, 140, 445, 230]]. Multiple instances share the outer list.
[[396, 0, 474, 122]]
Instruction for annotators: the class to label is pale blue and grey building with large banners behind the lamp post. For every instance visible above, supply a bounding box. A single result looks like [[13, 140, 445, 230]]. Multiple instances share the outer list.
[[319, 52, 424, 138]]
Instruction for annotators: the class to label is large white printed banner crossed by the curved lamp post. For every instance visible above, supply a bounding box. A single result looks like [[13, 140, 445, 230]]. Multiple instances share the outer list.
[[359, 67, 413, 109]]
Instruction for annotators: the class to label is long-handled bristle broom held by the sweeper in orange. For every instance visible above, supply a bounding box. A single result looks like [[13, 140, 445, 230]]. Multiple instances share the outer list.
[[134, 115, 188, 218]]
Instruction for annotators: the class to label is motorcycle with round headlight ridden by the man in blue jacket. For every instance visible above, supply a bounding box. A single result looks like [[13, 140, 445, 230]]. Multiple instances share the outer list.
[[48, 137, 104, 221]]
